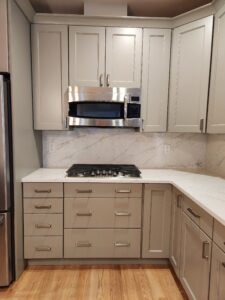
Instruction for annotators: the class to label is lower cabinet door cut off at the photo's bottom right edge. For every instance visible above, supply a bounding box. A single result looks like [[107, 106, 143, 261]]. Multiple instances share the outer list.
[[209, 243, 225, 300]]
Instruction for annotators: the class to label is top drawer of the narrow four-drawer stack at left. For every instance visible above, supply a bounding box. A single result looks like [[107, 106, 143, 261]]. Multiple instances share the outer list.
[[23, 182, 63, 198]]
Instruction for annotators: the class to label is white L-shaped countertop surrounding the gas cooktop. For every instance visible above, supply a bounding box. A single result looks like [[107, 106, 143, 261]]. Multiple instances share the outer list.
[[22, 168, 225, 226]]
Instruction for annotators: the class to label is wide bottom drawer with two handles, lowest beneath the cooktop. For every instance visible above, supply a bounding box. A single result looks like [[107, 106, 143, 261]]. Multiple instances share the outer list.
[[64, 229, 141, 258]]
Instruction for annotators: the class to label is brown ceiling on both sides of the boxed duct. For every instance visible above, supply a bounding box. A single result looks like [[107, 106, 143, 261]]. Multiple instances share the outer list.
[[30, 0, 212, 17]]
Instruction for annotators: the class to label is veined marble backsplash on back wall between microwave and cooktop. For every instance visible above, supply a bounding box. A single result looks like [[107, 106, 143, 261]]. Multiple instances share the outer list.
[[43, 128, 207, 170]]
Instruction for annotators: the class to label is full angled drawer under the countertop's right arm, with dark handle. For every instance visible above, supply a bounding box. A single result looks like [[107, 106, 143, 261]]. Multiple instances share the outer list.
[[183, 196, 213, 238]]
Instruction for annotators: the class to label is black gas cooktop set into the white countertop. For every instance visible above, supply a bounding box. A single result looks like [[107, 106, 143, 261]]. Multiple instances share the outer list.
[[66, 164, 141, 177]]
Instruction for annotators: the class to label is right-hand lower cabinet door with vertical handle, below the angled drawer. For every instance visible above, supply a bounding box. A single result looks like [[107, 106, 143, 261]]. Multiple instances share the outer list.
[[180, 212, 211, 300]]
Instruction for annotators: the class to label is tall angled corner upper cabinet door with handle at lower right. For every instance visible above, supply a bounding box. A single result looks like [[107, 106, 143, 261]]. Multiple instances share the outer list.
[[169, 16, 213, 132]]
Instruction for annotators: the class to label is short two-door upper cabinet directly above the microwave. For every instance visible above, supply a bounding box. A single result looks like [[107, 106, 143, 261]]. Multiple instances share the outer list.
[[69, 26, 142, 88]]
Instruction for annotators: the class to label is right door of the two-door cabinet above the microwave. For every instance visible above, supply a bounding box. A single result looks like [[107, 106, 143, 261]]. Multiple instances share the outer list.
[[106, 28, 142, 88]]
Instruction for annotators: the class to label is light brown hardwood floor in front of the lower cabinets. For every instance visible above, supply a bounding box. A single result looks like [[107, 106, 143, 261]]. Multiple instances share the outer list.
[[0, 265, 187, 300]]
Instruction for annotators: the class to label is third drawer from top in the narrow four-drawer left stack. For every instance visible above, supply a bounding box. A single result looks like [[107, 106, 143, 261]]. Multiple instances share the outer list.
[[24, 214, 63, 236]]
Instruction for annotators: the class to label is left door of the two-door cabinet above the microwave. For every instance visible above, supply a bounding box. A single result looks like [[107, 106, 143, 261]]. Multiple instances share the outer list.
[[69, 26, 105, 86]]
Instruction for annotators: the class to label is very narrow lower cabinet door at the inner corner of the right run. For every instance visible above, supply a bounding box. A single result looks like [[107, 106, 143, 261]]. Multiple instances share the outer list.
[[170, 189, 183, 277]]
